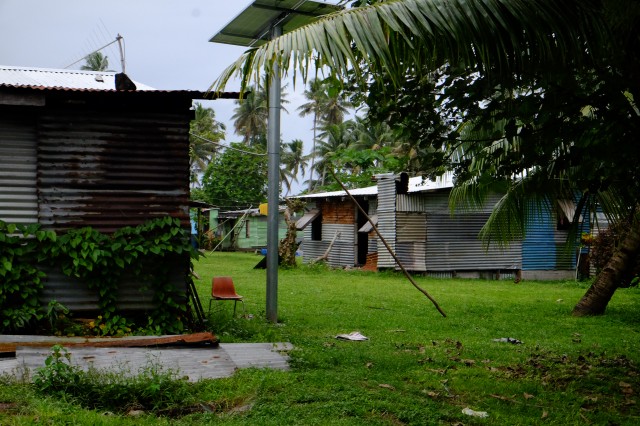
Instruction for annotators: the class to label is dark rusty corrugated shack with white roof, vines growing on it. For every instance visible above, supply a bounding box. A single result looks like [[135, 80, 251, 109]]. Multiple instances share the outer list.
[[0, 67, 238, 311]]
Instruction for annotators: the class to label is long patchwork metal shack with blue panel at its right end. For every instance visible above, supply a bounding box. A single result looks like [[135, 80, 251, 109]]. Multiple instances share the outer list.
[[298, 174, 576, 279]]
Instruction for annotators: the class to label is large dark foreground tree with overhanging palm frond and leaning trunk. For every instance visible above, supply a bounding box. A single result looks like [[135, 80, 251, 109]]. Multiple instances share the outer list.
[[213, 0, 640, 315]]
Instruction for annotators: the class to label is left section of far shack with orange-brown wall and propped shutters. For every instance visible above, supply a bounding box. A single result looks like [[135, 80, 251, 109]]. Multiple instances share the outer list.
[[296, 186, 377, 267]]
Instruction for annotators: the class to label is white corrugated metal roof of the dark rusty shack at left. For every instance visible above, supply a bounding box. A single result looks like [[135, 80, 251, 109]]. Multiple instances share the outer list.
[[0, 65, 155, 91]]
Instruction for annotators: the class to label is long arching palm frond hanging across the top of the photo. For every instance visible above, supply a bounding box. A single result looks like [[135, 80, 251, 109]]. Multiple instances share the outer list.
[[211, 0, 604, 91]]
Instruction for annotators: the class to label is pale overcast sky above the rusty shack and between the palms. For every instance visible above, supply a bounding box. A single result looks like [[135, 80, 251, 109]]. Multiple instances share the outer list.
[[0, 0, 335, 195]]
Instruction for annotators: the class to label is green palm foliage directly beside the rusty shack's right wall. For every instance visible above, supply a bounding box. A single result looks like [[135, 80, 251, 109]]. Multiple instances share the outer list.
[[189, 102, 226, 185]]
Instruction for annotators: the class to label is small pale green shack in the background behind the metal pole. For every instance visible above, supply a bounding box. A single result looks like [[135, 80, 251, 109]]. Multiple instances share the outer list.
[[216, 206, 287, 251]]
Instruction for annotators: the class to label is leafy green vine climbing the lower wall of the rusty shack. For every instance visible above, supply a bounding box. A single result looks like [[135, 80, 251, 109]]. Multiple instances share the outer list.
[[0, 217, 198, 335]]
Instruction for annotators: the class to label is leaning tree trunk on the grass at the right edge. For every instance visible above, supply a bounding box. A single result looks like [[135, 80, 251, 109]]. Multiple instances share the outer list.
[[573, 219, 640, 317]]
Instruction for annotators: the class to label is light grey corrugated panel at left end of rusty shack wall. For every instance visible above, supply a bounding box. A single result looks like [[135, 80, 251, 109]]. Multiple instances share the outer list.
[[0, 114, 38, 224]]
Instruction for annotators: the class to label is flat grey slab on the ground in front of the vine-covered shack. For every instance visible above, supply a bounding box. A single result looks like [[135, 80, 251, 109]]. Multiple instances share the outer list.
[[0, 343, 292, 381]]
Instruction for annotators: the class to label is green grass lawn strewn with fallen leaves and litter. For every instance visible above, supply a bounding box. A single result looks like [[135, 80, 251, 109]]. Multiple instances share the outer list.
[[0, 253, 640, 425]]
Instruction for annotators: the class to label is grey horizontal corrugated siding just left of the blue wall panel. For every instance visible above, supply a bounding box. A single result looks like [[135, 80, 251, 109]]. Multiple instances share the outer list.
[[426, 214, 522, 271]]
